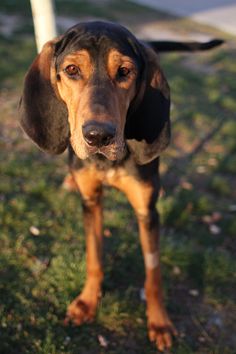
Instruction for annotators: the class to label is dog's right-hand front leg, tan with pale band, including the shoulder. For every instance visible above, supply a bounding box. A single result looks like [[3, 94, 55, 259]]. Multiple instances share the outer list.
[[114, 175, 176, 351]]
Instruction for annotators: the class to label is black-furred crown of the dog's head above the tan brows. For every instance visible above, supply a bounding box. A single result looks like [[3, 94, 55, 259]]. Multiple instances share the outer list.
[[55, 22, 143, 67]]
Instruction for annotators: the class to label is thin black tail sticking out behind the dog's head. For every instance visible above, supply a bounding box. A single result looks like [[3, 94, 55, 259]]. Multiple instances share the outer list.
[[145, 39, 224, 53]]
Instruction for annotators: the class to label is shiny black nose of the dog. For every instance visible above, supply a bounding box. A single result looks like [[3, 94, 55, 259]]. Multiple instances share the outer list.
[[82, 121, 116, 147]]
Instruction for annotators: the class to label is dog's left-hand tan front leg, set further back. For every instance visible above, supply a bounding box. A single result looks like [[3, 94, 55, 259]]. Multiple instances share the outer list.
[[66, 170, 103, 325]]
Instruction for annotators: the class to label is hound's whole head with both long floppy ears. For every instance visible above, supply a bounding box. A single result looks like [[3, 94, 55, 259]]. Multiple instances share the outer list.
[[20, 22, 170, 164]]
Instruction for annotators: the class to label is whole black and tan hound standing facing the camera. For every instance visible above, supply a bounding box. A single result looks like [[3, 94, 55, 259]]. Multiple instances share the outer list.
[[20, 22, 221, 350]]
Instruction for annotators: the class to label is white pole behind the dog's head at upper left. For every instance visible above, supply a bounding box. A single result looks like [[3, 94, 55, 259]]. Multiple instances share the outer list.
[[30, 0, 57, 52]]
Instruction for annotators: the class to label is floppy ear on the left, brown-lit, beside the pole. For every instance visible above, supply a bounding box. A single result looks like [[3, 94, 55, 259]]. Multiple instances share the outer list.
[[20, 41, 69, 154]]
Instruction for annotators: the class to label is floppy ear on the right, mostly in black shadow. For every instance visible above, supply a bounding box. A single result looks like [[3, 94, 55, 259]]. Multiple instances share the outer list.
[[125, 47, 170, 165]]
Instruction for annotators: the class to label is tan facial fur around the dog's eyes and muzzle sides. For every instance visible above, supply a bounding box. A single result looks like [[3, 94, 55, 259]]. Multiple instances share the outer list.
[[57, 49, 137, 160]]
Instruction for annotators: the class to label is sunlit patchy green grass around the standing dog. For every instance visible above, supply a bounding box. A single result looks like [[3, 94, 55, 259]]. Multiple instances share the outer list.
[[0, 1, 236, 354]]
